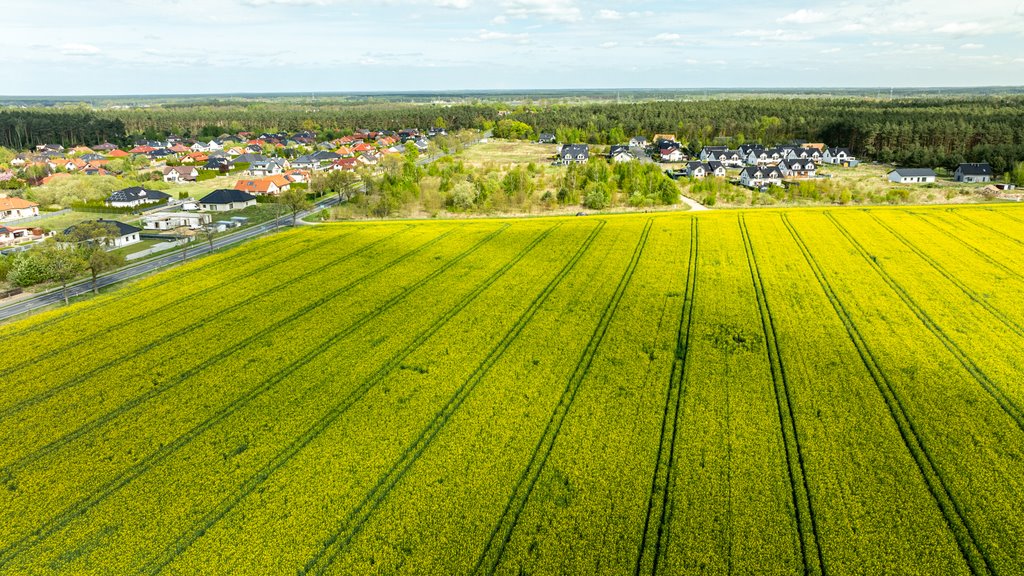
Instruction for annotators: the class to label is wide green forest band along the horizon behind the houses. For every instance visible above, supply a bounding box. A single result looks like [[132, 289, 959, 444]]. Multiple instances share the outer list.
[[0, 95, 1024, 172]]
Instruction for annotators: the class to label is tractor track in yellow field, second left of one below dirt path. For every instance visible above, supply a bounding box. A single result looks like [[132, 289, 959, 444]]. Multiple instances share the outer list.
[[299, 220, 605, 575]]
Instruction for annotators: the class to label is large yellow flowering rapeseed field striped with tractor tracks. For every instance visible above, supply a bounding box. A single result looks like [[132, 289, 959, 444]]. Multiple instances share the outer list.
[[0, 205, 1024, 575]]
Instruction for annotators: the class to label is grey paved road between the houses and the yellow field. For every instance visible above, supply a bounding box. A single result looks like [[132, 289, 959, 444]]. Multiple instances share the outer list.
[[0, 198, 338, 322]]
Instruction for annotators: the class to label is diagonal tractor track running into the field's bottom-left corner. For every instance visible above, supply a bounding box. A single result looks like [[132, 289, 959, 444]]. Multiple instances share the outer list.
[[0, 224, 508, 569]]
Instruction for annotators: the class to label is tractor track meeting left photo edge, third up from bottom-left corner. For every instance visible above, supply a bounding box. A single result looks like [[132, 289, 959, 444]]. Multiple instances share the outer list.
[[0, 224, 415, 426]]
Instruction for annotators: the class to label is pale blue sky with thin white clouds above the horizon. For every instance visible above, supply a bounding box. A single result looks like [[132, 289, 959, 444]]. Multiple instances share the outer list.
[[6, 0, 1024, 95]]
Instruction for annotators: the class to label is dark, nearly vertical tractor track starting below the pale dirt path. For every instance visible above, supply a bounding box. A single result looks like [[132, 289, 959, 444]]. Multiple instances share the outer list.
[[633, 218, 700, 576]]
